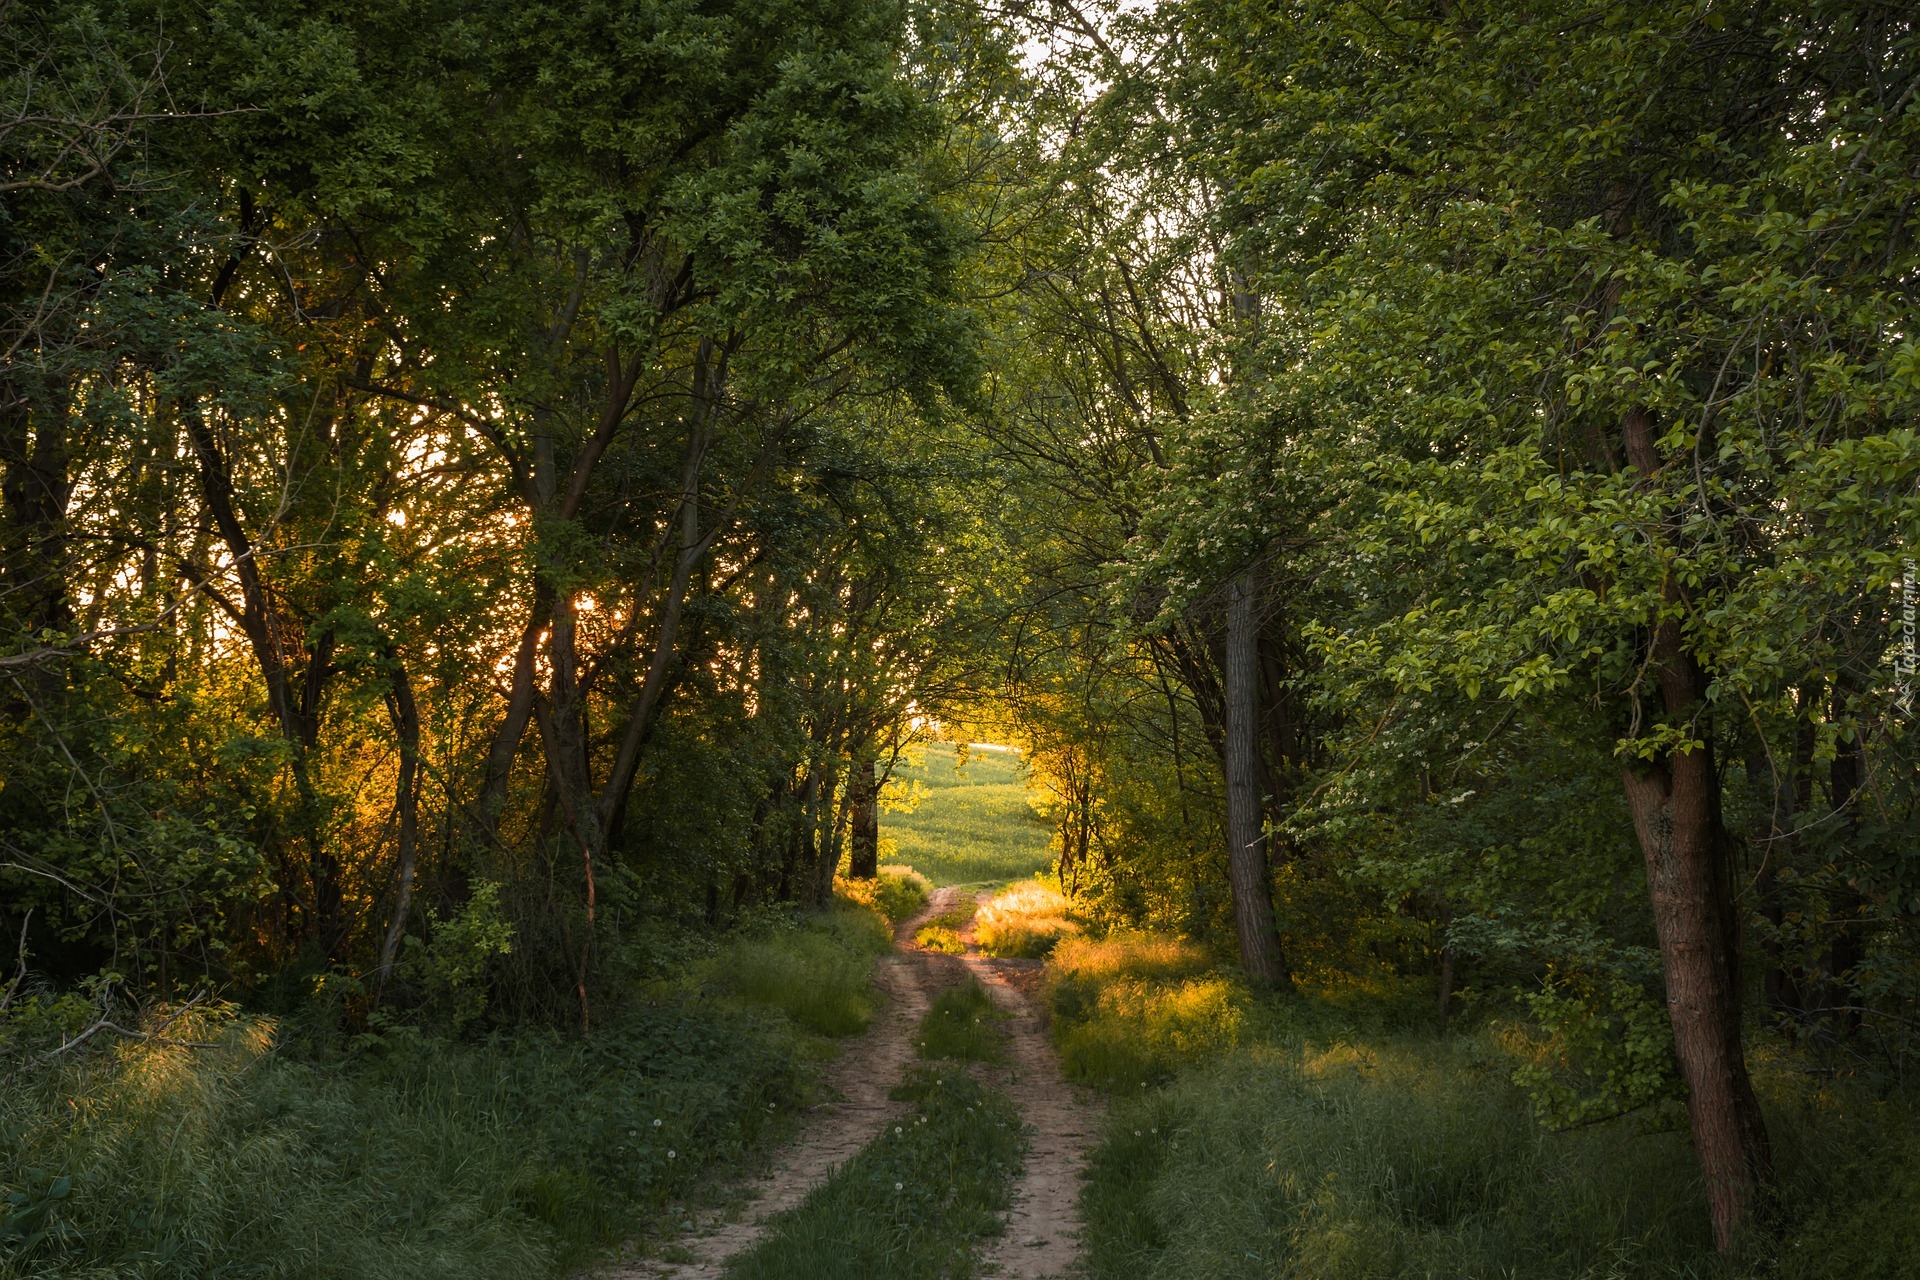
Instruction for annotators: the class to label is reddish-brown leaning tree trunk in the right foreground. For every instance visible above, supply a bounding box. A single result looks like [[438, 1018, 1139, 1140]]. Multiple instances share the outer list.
[[1622, 618, 1772, 1253]]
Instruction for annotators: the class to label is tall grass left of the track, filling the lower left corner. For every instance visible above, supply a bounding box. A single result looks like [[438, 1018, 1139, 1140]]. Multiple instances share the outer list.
[[0, 1000, 806, 1280]]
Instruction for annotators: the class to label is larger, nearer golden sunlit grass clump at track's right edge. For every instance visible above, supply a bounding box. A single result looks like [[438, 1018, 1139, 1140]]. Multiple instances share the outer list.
[[1048, 935, 1250, 1090]]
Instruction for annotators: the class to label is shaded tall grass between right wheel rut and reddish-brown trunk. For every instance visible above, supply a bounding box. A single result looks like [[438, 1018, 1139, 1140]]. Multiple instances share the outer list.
[[1083, 1036, 1711, 1280]]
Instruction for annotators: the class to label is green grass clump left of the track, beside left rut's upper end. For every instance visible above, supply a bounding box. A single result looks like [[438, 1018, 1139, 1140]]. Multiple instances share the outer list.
[[708, 906, 893, 1036]]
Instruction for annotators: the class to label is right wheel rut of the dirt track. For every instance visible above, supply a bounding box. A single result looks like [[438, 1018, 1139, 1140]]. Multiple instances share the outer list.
[[962, 894, 1102, 1280]]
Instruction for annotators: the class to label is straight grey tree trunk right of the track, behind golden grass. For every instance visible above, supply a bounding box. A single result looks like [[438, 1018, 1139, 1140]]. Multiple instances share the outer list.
[[1221, 568, 1292, 990]]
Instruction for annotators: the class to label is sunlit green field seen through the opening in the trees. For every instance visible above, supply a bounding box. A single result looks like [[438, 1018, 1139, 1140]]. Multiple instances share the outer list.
[[879, 745, 1050, 885]]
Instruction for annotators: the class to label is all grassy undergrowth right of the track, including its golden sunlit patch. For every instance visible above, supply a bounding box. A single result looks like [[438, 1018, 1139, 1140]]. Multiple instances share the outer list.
[[1050, 935, 1920, 1280]]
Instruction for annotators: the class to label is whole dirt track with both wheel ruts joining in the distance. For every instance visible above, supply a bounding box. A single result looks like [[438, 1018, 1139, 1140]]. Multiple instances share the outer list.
[[597, 889, 1100, 1280]]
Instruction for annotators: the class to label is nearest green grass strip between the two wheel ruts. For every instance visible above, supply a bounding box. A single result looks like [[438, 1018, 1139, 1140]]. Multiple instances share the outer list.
[[726, 1067, 1025, 1280]]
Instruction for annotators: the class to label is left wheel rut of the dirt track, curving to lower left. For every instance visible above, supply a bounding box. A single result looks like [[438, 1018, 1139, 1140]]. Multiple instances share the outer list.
[[597, 892, 952, 1280]]
